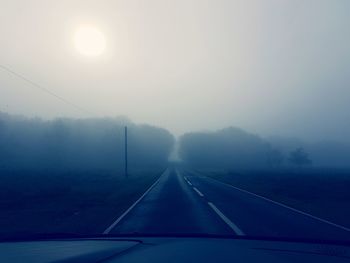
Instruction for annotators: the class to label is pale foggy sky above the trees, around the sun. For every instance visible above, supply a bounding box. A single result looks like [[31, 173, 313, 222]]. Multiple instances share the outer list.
[[0, 0, 350, 141]]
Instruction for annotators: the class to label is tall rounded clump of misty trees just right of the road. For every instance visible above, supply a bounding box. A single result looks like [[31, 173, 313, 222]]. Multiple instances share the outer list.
[[179, 127, 281, 169]]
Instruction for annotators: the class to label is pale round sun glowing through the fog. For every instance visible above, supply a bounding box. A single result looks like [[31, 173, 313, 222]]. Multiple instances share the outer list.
[[74, 25, 106, 57]]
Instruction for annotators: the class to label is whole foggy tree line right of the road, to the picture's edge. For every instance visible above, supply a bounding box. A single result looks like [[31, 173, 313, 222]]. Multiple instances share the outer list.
[[178, 127, 350, 171]]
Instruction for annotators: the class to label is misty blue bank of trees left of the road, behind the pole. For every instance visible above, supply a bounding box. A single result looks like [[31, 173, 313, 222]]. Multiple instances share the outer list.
[[0, 113, 175, 170]]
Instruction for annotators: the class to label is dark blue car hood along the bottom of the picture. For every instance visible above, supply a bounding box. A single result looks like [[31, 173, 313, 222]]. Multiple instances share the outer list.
[[0, 237, 350, 263]]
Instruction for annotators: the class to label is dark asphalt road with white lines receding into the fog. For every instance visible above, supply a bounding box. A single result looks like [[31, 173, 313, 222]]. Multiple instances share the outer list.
[[104, 169, 350, 240]]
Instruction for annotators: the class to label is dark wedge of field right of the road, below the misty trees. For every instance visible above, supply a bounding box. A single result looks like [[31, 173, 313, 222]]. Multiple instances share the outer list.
[[201, 169, 350, 227]]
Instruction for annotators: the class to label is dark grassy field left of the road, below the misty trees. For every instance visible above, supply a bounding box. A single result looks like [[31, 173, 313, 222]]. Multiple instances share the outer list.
[[0, 169, 163, 236]]
